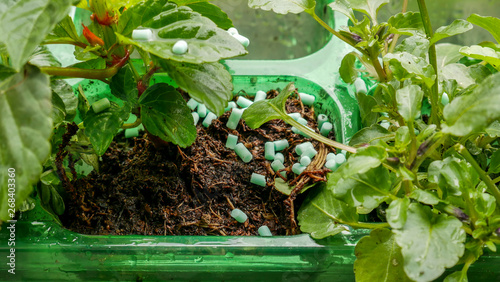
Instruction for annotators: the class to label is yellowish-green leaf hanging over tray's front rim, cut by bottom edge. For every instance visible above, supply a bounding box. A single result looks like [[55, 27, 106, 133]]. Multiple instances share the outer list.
[[354, 229, 411, 282]]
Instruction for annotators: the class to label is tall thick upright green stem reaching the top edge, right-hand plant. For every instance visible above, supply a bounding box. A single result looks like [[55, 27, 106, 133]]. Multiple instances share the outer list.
[[418, 0, 440, 127]]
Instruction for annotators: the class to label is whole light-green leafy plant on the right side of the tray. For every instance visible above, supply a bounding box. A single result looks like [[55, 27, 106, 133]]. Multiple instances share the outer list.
[[244, 0, 500, 281]]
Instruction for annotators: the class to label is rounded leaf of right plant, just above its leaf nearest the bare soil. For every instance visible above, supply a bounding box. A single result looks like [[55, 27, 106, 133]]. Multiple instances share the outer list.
[[328, 165, 392, 209]]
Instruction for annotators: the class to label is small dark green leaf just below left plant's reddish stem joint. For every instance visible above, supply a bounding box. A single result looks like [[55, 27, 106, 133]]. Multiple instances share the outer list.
[[109, 64, 139, 104]]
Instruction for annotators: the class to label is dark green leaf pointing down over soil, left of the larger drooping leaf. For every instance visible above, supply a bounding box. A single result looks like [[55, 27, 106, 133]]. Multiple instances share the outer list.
[[83, 102, 130, 156]]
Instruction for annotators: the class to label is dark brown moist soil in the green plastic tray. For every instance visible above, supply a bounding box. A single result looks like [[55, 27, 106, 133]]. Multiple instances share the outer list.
[[61, 91, 333, 235]]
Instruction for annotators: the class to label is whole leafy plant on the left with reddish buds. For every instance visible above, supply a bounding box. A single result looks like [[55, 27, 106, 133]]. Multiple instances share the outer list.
[[0, 0, 246, 222]]
